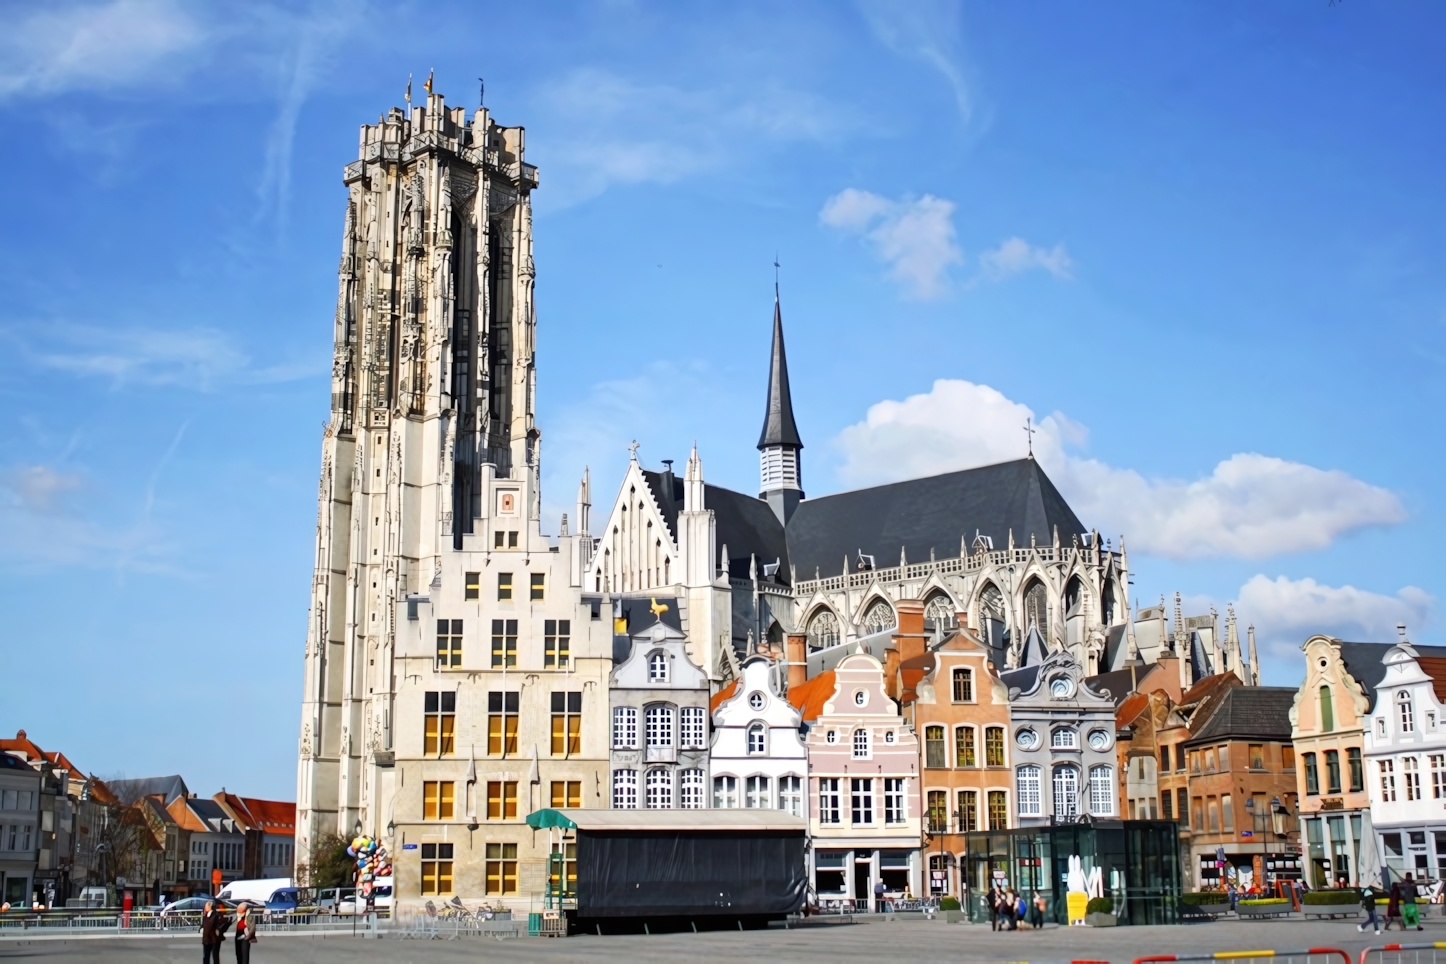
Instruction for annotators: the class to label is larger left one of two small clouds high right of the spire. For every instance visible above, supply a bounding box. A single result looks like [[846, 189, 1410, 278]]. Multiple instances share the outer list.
[[818, 188, 964, 298]]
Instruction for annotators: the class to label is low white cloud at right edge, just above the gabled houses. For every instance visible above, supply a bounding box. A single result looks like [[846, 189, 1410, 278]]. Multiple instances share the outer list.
[[1236, 575, 1436, 658]]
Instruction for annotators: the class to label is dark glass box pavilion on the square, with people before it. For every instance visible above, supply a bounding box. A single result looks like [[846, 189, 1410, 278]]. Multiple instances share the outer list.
[[963, 819, 1180, 924]]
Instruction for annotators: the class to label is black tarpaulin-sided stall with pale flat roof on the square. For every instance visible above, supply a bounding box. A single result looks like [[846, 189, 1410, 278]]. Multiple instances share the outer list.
[[528, 809, 808, 929]]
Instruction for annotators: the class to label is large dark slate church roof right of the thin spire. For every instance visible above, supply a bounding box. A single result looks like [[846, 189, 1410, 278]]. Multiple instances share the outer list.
[[780, 458, 1086, 578]]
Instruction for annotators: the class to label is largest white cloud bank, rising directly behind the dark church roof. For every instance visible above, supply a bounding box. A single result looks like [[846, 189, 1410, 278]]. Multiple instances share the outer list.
[[836, 379, 1406, 559]]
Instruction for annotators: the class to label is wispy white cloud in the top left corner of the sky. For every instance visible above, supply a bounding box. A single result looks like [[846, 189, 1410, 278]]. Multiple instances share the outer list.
[[0, 0, 205, 98]]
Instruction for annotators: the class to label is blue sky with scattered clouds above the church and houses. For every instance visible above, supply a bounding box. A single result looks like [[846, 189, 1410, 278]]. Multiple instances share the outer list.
[[0, 0, 1446, 799]]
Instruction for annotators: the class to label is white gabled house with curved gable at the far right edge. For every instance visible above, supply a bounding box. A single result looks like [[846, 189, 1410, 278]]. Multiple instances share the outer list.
[[1365, 642, 1446, 880]]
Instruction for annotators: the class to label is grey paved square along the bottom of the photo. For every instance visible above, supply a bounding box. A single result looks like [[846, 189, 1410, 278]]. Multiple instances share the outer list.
[[0, 919, 1446, 964]]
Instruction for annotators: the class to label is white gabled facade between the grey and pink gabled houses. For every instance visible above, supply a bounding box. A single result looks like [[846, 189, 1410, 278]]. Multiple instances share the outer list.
[[711, 656, 808, 817]]
